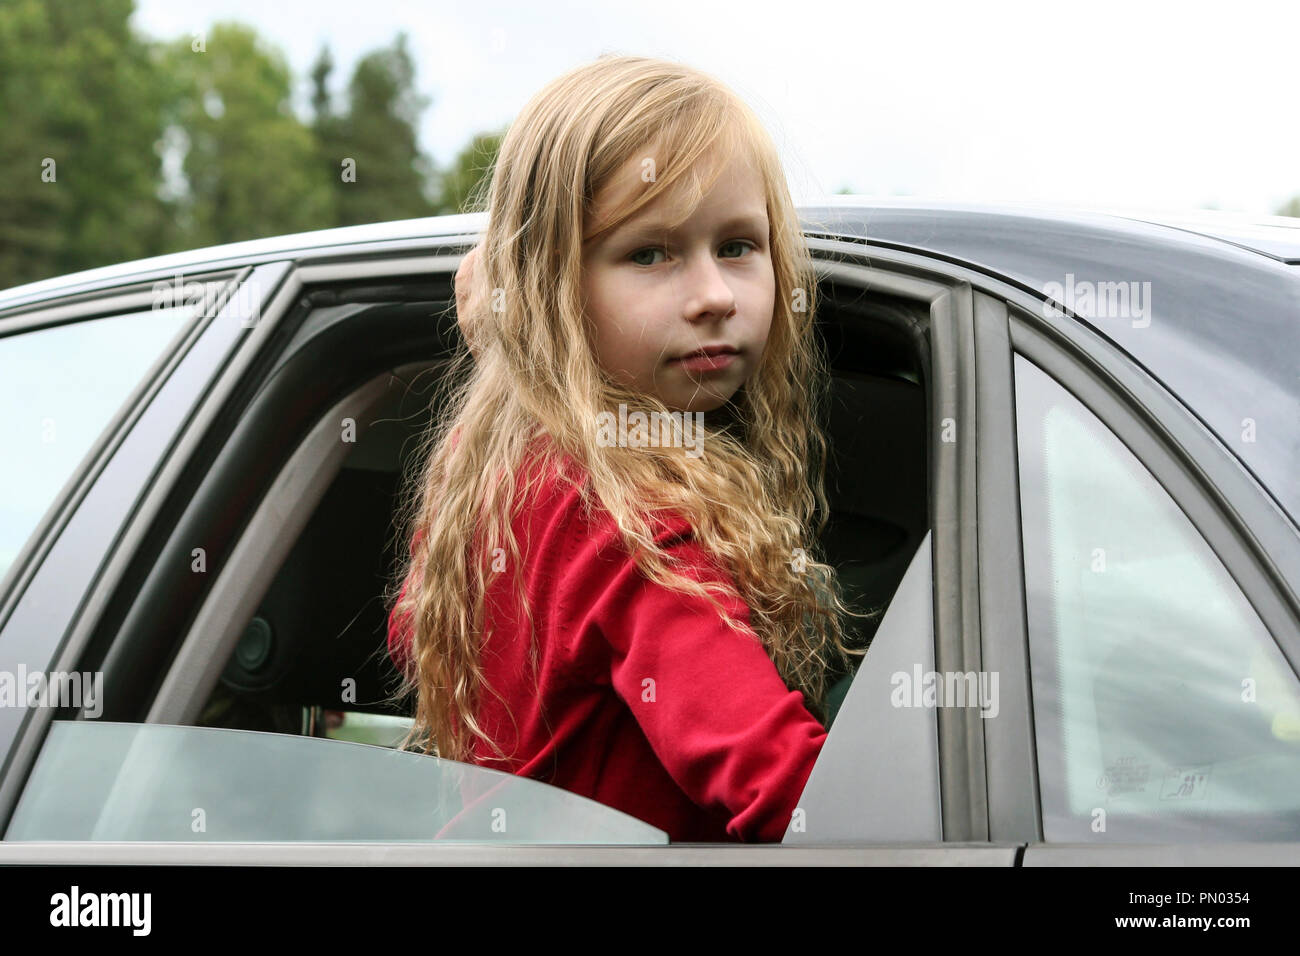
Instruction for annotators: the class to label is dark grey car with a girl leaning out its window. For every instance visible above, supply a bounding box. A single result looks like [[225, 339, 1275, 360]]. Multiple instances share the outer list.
[[0, 196, 1300, 866]]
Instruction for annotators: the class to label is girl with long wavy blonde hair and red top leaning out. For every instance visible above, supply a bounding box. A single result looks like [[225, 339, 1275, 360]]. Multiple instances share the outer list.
[[389, 56, 862, 842]]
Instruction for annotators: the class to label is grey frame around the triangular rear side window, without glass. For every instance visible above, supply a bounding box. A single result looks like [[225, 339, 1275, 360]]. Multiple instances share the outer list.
[[975, 257, 1300, 866]]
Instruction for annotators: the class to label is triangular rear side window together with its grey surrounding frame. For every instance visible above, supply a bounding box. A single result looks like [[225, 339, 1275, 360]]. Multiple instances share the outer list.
[[975, 282, 1300, 865]]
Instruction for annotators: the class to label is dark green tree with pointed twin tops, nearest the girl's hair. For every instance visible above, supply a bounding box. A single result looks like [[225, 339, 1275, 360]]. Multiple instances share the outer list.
[[312, 33, 437, 225]]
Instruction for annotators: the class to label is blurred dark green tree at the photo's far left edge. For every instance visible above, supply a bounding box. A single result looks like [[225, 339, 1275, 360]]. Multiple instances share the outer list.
[[0, 0, 178, 289]]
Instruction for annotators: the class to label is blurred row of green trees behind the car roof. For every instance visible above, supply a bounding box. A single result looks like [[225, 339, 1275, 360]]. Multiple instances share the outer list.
[[0, 0, 504, 289]]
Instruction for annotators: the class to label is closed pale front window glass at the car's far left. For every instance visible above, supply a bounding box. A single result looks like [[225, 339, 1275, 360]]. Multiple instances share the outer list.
[[0, 304, 194, 580]]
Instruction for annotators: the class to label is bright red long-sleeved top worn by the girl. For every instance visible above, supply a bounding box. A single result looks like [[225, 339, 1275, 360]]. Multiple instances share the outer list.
[[389, 444, 827, 843]]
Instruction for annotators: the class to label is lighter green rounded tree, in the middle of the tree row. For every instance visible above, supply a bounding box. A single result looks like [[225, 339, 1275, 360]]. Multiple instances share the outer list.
[[165, 22, 333, 246]]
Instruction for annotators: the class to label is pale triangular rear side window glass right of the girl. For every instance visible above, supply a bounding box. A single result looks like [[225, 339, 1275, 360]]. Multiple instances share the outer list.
[[1015, 356, 1300, 842]]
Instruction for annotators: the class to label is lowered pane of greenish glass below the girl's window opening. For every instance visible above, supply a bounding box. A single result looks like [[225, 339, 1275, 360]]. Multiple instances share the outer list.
[[5, 721, 668, 844]]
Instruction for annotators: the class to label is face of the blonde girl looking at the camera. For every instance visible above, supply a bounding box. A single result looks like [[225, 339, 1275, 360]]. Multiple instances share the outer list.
[[582, 150, 776, 411]]
